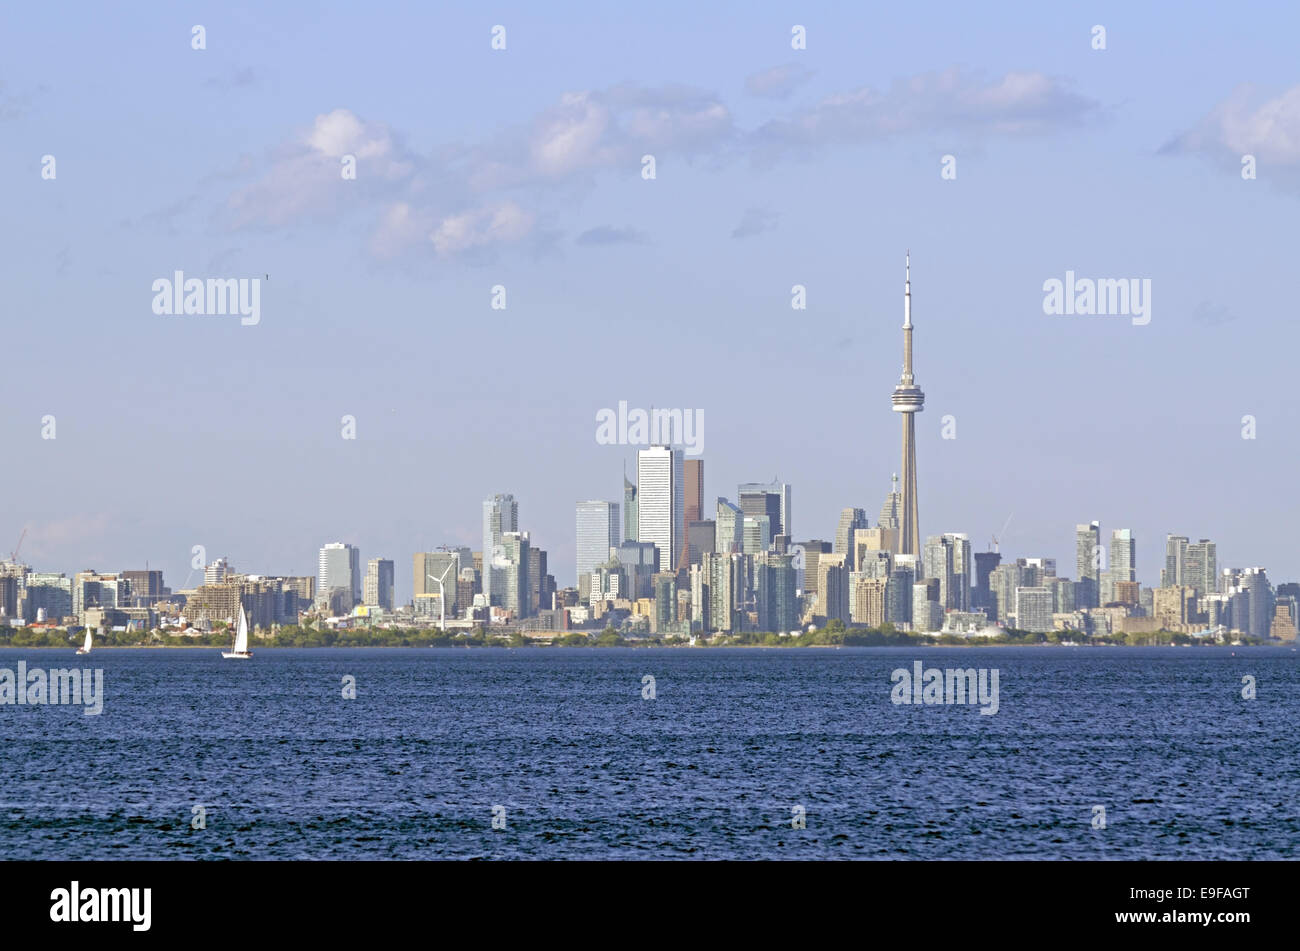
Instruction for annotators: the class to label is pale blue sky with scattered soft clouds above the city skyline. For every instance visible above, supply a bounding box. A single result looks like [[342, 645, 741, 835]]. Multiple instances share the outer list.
[[0, 3, 1300, 602]]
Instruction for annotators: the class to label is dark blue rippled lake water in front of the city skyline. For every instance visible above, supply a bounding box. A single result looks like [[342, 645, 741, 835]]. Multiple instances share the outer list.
[[0, 647, 1300, 859]]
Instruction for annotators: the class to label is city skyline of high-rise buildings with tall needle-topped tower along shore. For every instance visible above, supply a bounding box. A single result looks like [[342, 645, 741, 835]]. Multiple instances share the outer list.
[[0, 255, 1300, 640]]
